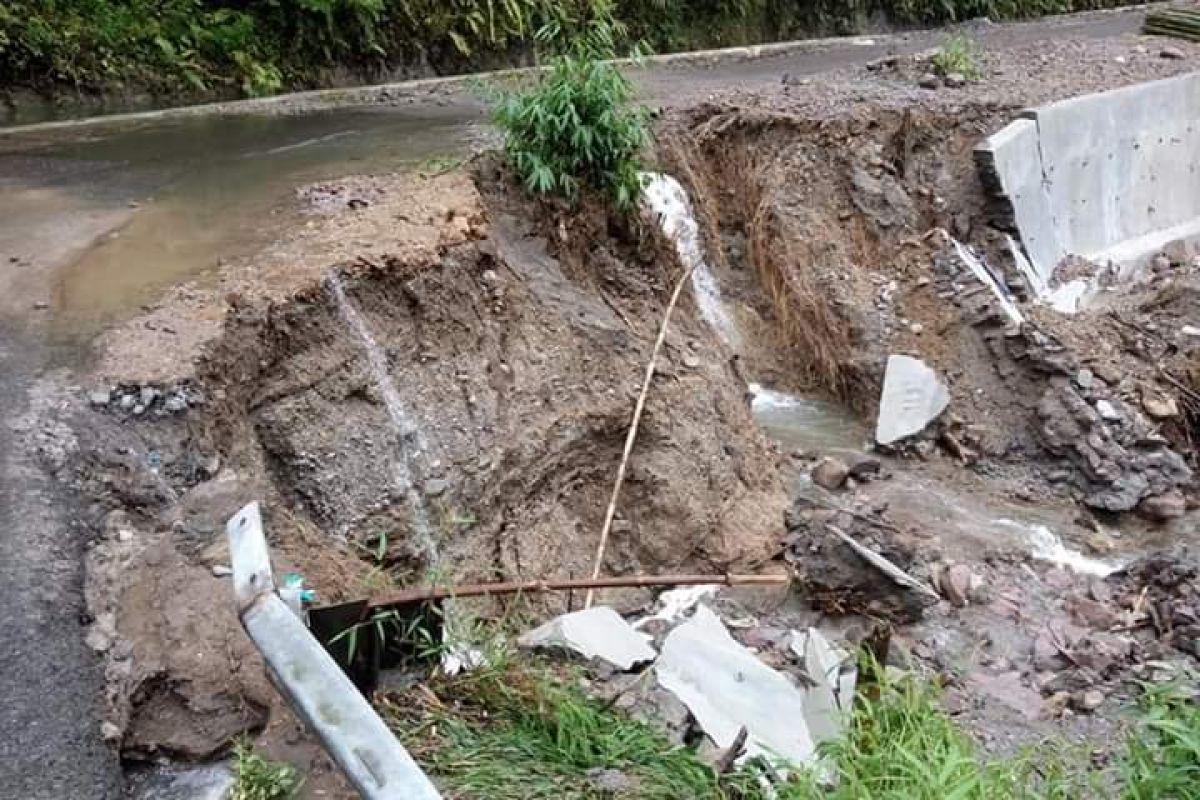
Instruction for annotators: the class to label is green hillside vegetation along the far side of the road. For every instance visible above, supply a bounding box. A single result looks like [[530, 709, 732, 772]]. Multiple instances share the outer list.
[[0, 0, 1142, 95]]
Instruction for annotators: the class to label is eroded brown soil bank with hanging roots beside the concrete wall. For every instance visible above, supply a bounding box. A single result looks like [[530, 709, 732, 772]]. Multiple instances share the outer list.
[[664, 76, 1196, 518]]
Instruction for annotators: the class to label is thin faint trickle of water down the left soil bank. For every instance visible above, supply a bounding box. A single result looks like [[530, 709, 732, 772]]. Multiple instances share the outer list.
[[326, 270, 437, 563]]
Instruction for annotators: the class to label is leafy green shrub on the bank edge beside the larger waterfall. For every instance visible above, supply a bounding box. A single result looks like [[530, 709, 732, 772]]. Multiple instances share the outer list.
[[494, 2, 648, 210]]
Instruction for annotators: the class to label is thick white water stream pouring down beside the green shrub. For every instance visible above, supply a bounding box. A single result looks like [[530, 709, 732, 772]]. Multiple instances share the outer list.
[[642, 173, 738, 347]]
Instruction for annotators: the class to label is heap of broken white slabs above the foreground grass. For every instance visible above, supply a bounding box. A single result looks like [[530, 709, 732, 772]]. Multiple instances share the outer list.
[[521, 589, 857, 769]]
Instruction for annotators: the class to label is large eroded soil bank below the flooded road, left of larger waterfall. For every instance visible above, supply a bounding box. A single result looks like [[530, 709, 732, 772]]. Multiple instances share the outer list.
[[72, 169, 786, 777]]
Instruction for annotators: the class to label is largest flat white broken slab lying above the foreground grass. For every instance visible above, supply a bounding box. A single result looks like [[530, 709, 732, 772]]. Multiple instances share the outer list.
[[655, 606, 816, 765]]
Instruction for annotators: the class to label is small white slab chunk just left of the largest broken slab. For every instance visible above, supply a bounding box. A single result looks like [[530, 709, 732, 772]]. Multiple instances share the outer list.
[[518, 606, 658, 669]]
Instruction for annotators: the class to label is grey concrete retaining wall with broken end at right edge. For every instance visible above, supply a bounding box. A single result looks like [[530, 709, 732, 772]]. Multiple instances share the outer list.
[[976, 73, 1200, 284]]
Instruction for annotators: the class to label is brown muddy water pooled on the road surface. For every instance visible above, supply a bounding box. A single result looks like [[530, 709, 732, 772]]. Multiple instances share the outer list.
[[0, 108, 485, 330]]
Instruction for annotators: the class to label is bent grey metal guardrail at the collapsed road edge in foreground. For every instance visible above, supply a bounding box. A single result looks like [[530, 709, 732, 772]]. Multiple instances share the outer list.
[[226, 503, 442, 800]]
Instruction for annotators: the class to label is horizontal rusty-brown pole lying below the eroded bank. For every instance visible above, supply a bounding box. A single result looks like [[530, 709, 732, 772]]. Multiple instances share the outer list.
[[367, 573, 791, 609]]
